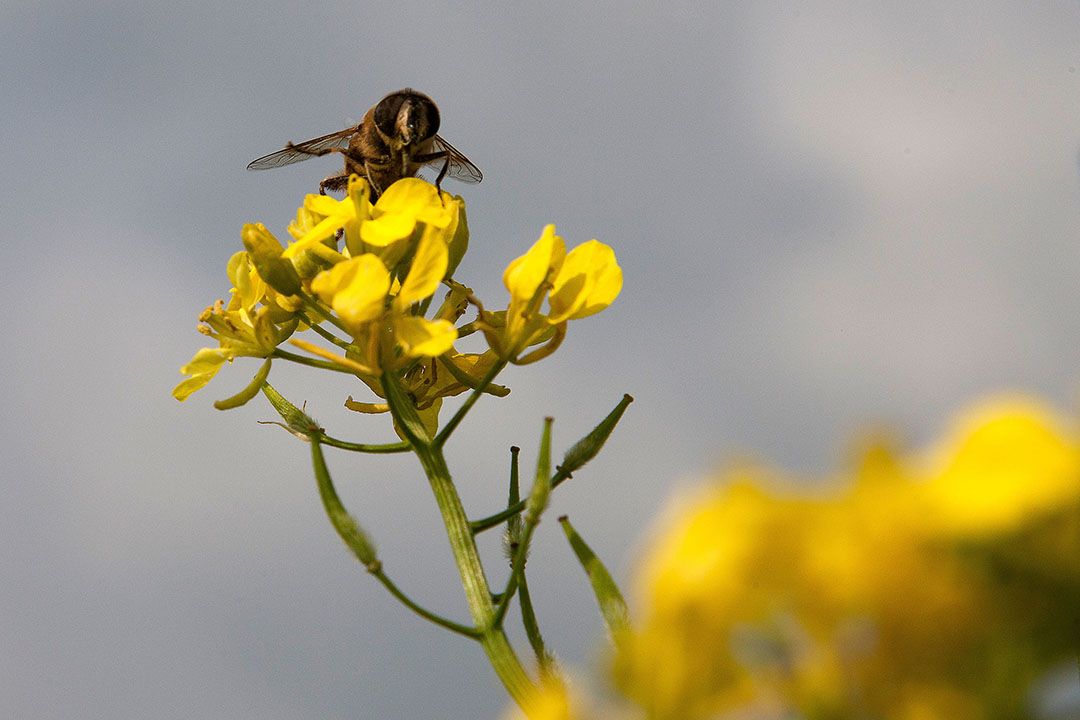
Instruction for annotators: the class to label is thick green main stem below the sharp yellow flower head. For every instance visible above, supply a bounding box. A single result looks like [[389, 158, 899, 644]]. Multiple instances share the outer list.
[[415, 446, 536, 710]]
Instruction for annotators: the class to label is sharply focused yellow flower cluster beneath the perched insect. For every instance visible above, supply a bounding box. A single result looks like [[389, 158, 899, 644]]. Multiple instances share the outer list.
[[173, 176, 622, 423]]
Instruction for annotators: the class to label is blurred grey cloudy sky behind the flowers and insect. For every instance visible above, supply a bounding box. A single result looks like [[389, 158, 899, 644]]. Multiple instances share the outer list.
[[0, 1, 1080, 720]]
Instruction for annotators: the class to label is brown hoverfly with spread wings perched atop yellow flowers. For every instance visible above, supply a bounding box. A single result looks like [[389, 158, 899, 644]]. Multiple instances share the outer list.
[[247, 87, 484, 202]]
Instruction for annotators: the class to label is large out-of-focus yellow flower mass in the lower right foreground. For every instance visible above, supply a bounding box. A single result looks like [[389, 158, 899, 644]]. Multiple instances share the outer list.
[[505, 398, 1080, 720]]
